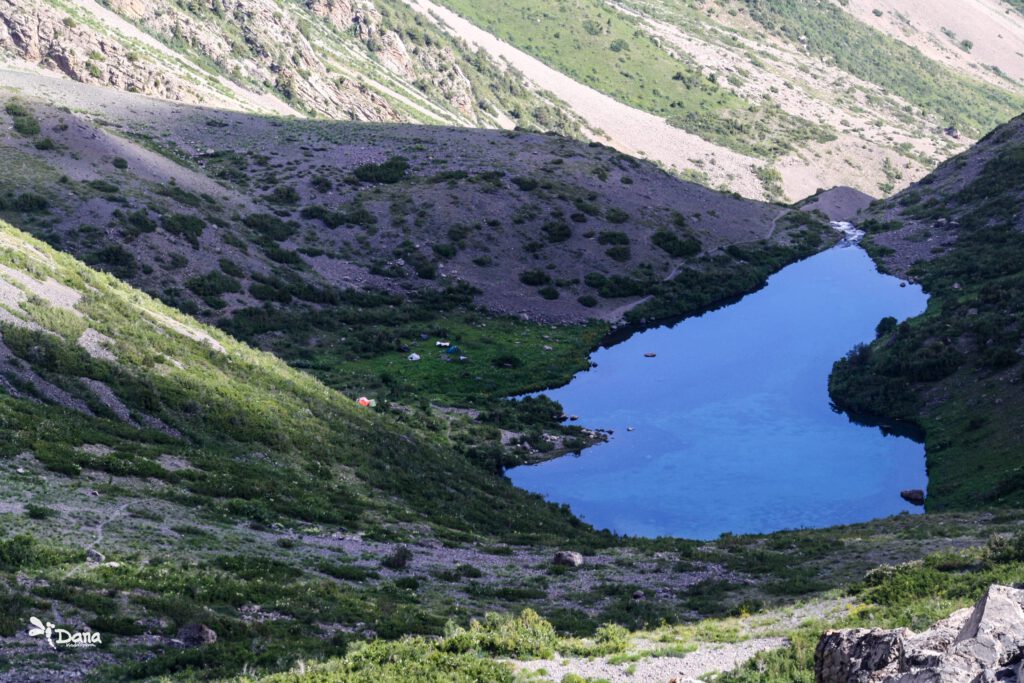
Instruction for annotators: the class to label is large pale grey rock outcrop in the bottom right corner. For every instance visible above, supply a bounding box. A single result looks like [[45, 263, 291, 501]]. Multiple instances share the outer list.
[[814, 586, 1024, 683]]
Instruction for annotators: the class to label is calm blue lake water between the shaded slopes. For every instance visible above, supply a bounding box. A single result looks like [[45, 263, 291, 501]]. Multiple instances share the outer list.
[[508, 246, 927, 539]]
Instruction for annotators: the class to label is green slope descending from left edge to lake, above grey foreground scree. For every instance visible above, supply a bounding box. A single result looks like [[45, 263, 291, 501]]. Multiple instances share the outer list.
[[0, 216, 598, 530]]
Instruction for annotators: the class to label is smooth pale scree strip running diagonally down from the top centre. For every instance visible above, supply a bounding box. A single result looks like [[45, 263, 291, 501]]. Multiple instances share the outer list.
[[406, 0, 764, 199]]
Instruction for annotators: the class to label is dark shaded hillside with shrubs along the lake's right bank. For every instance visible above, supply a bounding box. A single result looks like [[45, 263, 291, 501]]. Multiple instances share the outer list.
[[831, 118, 1024, 510]]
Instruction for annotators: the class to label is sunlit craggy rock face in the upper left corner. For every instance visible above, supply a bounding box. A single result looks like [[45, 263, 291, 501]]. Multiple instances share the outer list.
[[0, 0, 477, 122]]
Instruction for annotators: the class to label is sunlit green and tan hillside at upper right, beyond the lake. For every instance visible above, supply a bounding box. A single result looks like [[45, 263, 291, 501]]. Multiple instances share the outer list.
[[423, 0, 1024, 200]]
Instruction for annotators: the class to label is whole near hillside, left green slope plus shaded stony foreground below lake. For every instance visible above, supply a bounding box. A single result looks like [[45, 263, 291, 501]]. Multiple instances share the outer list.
[[6, 208, 1021, 681]]
